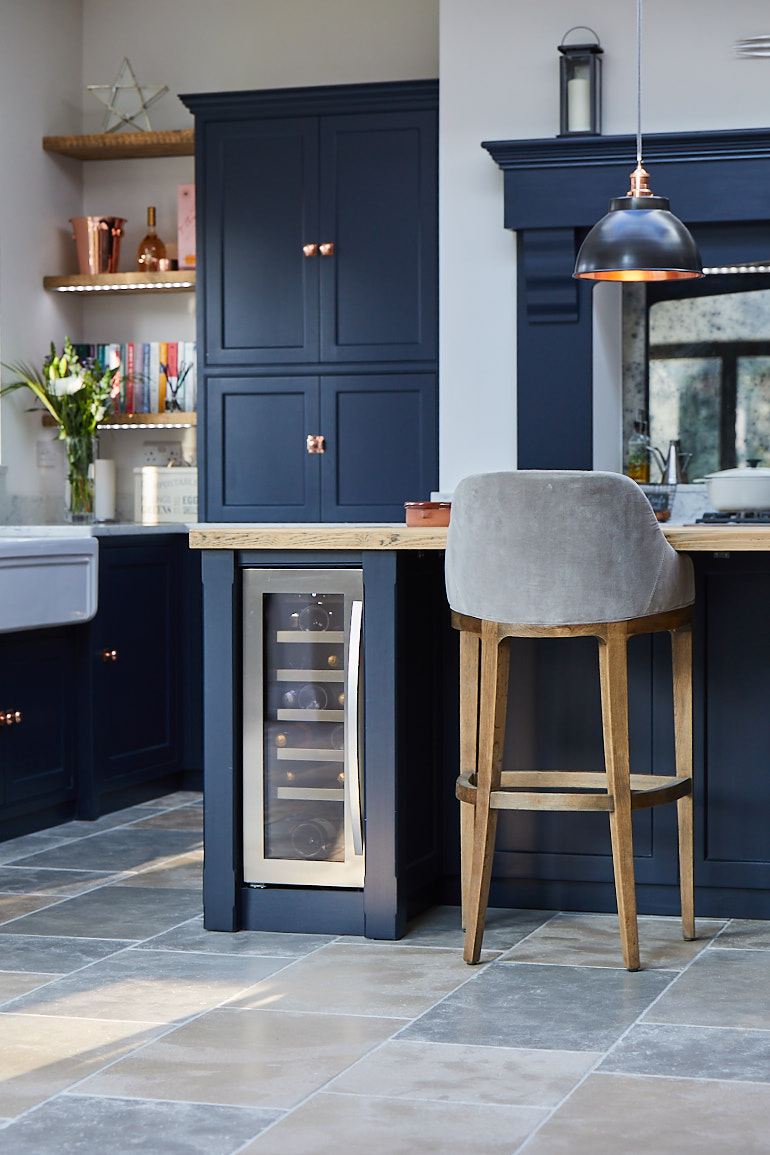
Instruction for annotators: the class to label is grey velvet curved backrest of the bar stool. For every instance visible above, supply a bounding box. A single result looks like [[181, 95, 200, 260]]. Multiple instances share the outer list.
[[446, 469, 695, 626]]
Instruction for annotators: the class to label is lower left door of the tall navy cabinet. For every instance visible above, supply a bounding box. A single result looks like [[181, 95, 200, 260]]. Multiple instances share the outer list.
[[205, 377, 322, 521]]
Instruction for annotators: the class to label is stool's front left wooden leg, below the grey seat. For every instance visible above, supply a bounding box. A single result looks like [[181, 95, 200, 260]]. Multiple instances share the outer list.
[[463, 621, 510, 963]]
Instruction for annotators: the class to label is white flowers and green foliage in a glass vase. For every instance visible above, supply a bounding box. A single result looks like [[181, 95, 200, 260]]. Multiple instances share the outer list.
[[0, 337, 120, 522]]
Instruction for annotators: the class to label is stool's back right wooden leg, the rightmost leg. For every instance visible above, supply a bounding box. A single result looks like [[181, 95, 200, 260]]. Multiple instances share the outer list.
[[671, 626, 695, 940]]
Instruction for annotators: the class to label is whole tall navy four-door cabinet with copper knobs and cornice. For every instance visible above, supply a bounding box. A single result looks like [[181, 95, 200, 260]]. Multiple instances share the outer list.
[[177, 81, 438, 521]]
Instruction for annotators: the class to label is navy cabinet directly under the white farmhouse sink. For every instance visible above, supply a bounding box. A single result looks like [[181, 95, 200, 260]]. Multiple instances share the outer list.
[[0, 626, 82, 839]]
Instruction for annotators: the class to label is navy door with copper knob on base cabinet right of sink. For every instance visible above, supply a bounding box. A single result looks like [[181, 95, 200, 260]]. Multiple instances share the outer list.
[[91, 545, 181, 787]]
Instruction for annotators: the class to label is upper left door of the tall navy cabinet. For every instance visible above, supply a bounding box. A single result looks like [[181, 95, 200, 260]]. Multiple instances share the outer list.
[[201, 118, 319, 365]]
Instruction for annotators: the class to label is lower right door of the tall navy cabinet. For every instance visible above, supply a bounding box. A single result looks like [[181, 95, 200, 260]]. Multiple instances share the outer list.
[[321, 373, 438, 521]]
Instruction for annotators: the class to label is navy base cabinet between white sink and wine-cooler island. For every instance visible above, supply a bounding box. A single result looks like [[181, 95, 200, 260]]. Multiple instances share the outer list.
[[79, 534, 202, 819]]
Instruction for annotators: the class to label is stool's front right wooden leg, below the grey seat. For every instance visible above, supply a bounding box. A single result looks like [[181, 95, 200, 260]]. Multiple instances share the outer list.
[[599, 625, 640, 970]]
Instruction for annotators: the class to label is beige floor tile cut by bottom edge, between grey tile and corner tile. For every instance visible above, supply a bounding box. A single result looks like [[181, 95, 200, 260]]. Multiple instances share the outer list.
[[237, 1094, 545, 1155]]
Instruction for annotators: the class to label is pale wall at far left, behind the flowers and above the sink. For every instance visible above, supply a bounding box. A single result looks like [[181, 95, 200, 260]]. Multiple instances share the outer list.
[[0, 0, 81, 517]]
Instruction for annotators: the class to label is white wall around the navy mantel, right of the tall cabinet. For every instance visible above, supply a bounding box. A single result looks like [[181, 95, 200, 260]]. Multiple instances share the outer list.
[[439, 0, 770, 490]]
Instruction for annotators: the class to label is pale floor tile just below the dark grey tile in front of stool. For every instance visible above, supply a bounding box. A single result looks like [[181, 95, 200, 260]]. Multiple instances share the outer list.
[[328, 1038, 599, 1106]]
